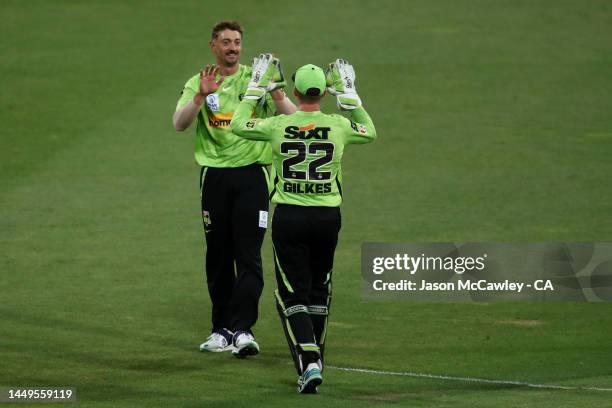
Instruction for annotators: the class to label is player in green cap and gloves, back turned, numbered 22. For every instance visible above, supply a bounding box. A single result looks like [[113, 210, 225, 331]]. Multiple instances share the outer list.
[[231, 56, 376, 393]]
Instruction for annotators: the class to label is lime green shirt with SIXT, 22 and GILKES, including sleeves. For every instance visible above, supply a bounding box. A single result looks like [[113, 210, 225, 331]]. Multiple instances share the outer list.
[[231, 100, 376, 207]]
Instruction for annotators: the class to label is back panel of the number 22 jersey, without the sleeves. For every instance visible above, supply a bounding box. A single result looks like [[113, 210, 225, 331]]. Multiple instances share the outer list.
[[270, 111, 355, 207]]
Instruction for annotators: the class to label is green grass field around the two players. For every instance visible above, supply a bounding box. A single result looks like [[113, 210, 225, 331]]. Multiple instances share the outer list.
[[0, 0, 612, 408]]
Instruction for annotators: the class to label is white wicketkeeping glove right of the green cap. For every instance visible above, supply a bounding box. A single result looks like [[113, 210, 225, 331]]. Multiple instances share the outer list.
[[325, 58, 361, 110]]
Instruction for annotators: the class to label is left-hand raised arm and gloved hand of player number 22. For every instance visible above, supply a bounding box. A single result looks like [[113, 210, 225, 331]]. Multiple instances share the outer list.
[[230, 54, 284, 140]]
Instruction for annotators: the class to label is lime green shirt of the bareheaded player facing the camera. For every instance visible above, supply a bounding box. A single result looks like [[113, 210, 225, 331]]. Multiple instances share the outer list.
[[176, 65, 276, 167]]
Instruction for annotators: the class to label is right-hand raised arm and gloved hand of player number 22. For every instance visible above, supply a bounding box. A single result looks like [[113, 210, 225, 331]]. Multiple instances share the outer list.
[[325, 59, 377, 143]]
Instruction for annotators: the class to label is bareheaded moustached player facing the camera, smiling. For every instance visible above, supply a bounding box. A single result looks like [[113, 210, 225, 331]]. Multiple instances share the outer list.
[[173, 21, 296, 357]]
